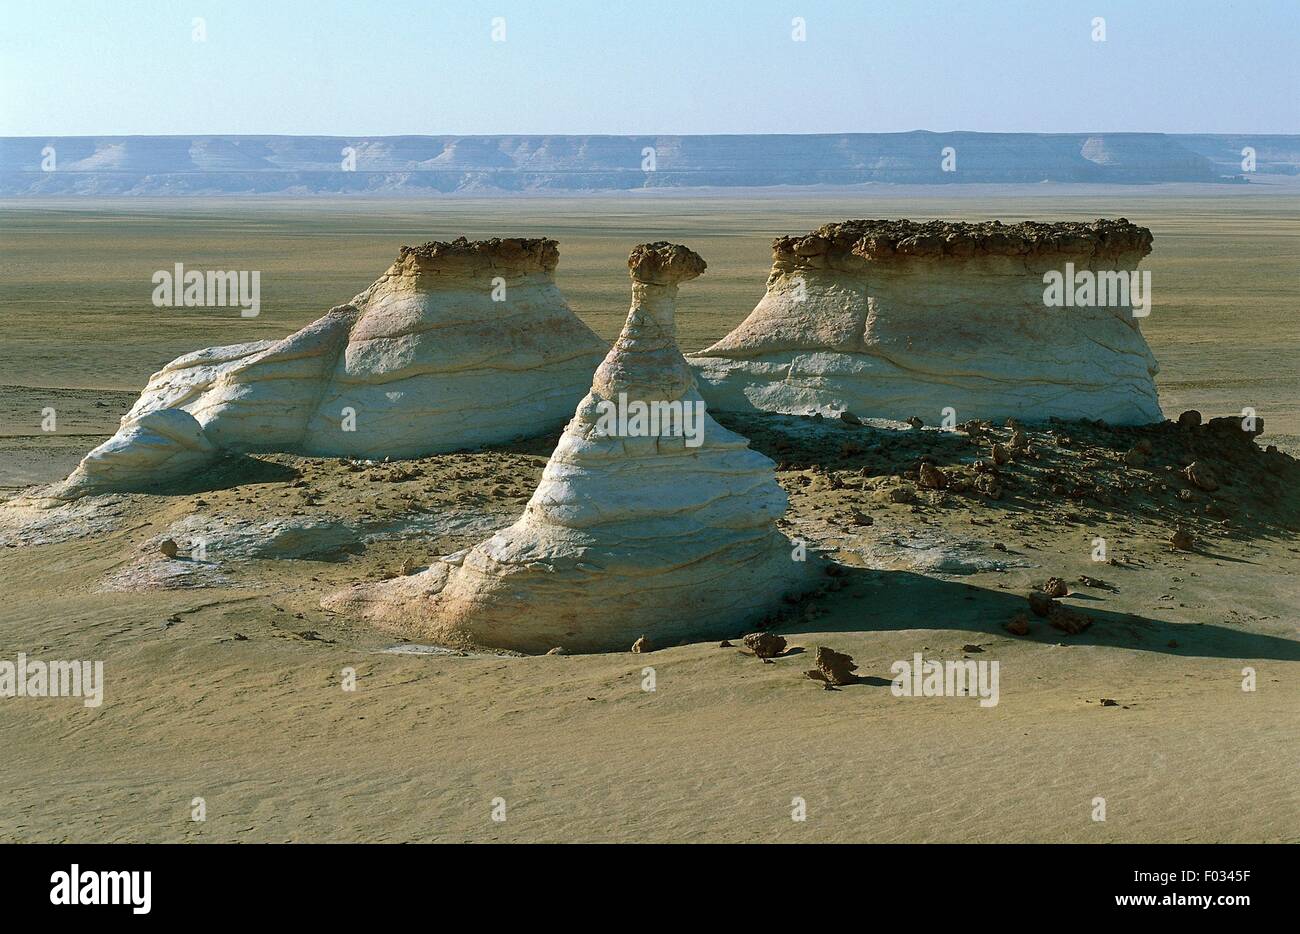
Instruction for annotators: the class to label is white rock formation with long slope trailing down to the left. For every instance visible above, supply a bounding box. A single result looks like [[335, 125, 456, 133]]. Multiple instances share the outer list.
[[56, 238, 606, 496]]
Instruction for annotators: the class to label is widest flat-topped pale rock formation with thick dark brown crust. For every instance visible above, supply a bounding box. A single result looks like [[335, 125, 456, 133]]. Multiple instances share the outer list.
[[690, 219, 1162, 424]]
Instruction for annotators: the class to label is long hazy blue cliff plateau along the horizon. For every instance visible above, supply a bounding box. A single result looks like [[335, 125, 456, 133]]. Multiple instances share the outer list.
[[0, 130, 1300, 196]]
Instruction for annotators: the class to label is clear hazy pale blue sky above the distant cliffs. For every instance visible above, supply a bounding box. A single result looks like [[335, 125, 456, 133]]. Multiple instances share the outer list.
[[0, 0, 1300, 135]]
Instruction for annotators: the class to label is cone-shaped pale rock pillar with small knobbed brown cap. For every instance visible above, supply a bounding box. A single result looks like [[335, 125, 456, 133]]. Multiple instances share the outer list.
[[324, 243, 811, 653]]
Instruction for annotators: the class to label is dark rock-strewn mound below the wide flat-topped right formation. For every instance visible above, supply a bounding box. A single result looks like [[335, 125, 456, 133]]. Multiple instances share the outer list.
[[719, 405, 1300, 582]]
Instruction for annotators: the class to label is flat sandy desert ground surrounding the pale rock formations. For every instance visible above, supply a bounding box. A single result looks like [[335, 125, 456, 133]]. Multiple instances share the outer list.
[[0, 186, 1300, 842]]
